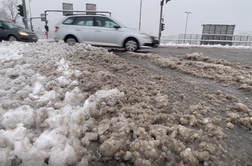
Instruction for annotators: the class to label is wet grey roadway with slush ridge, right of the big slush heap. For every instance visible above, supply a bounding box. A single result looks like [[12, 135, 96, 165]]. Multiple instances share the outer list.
[[115, 47, 252, 165]]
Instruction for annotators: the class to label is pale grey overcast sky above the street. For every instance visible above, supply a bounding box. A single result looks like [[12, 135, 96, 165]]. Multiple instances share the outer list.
[[0, 0, 252, 36]]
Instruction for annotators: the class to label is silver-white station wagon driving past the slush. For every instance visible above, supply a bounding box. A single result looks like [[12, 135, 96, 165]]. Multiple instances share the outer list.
[[55, 15, 158, 51]]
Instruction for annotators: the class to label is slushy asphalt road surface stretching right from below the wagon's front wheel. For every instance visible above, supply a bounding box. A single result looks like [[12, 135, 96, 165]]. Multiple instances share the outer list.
[[110, 47, 252, 165]]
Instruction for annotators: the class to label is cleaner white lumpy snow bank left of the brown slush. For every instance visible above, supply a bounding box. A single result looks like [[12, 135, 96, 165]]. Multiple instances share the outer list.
[[0, 42, 126, 166]]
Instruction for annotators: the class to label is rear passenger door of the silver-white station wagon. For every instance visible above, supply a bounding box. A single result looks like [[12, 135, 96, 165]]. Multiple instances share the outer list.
[[73, 16, 95, 44]]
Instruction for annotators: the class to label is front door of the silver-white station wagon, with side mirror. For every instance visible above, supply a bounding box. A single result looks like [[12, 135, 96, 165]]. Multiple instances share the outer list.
[[94, 16, 123, 46]]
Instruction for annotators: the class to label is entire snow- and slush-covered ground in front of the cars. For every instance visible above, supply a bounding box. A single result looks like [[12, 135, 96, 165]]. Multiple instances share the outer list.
[[0, 42, 252, 166]]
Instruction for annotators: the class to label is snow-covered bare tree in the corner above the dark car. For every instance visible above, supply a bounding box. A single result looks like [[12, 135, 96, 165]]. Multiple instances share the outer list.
[[3, 0, 18, 20]]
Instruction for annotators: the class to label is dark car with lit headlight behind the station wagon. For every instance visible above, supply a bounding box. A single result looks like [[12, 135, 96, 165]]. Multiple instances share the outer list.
[[0, 20, 38, 42]]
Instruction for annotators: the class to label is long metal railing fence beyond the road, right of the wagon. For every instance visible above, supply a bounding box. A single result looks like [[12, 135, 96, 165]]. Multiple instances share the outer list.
[[160, 34, 252, 46]]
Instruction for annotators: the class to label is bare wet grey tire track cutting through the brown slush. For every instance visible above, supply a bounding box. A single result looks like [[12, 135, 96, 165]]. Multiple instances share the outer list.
[[116, 52, 252, 165]]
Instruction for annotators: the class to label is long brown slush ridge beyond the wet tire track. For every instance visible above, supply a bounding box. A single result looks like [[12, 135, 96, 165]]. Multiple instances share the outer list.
[[128, 52, 252, 91]]
